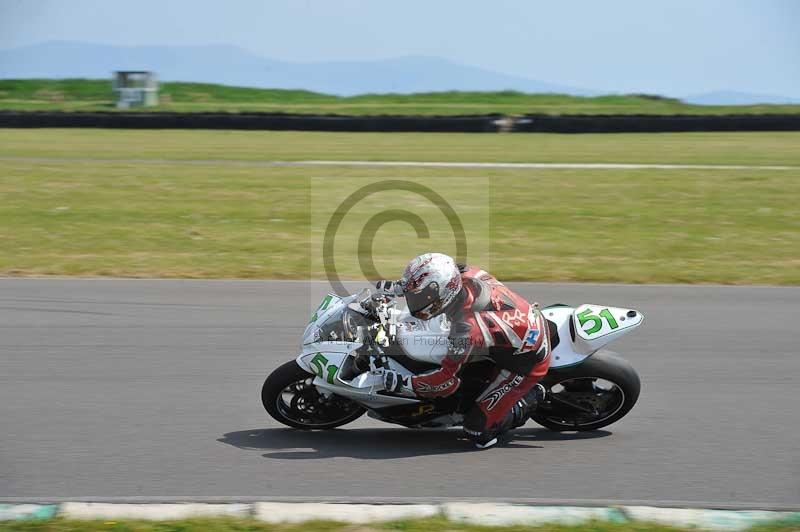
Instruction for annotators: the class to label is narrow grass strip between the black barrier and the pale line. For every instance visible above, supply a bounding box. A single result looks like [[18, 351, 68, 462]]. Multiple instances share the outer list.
[[0, 128, 800, 166]]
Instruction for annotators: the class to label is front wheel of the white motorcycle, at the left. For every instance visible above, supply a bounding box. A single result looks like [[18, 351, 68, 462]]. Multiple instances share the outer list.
[[261, 360, 366, 430]]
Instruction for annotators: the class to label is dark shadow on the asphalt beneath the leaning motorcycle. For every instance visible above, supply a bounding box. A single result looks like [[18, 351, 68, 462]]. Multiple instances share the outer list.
[[217, 428, 611, 460]]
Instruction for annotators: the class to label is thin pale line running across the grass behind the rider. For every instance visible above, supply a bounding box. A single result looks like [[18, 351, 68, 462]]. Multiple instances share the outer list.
[[0, 157, 800, 171]]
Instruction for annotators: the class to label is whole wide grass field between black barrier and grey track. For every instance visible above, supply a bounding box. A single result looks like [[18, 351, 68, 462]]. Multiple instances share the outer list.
[[0, 130, 800, 284]]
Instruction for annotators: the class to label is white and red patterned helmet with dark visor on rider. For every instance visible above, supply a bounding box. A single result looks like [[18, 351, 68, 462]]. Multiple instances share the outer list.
[[400, 253, 461, 320]]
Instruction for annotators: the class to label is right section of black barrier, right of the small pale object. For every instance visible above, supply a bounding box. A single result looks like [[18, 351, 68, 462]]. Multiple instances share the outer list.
[[512, 114, 800, 133]]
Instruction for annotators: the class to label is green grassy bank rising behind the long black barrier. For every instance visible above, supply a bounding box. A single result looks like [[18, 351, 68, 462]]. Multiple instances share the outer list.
[[0, 79, 800, 115]]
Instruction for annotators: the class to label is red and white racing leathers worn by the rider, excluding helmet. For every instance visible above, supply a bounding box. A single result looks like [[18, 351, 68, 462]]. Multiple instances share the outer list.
[[411, 266, 550, 441]]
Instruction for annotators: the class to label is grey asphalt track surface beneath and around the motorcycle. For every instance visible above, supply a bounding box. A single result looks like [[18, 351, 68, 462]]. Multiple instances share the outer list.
[[0, 279, 800, 508]]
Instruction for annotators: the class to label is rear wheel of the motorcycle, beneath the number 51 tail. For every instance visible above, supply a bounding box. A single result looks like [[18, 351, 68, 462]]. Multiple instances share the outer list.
[[531, 351, 641, 431]]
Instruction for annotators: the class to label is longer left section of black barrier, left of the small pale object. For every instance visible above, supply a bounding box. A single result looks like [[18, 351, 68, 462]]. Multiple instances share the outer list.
[[0, 111, 501, 133]]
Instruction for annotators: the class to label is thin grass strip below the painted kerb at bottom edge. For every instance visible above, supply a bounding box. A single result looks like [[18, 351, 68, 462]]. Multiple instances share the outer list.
[[0, 518, 800, 532]]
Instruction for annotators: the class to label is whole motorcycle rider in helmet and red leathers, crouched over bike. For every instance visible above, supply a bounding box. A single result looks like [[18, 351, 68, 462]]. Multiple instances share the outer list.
[[377, 253, 550, 449]]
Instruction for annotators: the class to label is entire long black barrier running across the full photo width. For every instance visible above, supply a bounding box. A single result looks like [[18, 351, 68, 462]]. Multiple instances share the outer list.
[[0, 111, 800, 133]]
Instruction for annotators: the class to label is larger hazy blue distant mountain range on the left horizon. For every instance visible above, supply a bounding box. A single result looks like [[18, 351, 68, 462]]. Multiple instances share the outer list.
[[0, 42, 597, 95]]
